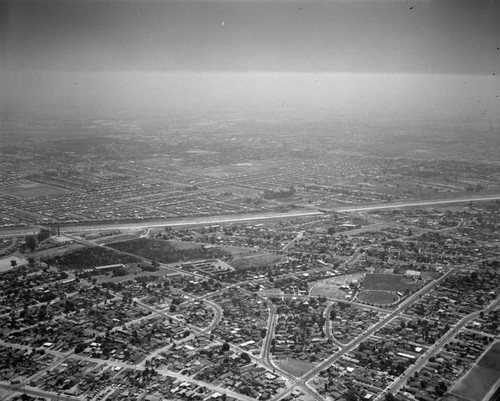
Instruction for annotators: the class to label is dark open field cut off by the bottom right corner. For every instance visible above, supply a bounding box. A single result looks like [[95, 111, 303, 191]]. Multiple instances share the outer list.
[[450, 341, 500, 401]]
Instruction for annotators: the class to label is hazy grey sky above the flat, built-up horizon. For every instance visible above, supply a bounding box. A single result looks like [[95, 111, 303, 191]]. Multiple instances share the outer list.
[[0, 0, 500, 118]]
